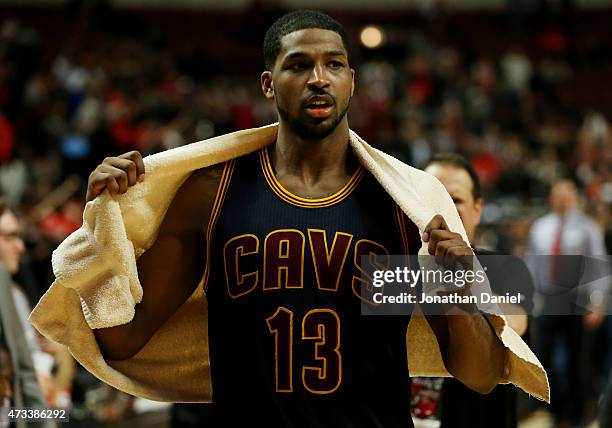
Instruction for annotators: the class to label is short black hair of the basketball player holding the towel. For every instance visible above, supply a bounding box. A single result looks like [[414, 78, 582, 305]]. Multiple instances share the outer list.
[[263, 10, 349, 70]]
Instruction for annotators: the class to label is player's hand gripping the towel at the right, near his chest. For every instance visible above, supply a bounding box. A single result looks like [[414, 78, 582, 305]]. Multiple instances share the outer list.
[[422, 214, 474, 270]]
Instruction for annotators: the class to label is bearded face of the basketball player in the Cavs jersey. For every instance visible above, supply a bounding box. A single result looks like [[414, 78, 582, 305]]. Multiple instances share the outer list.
[[261, 28, 355, 139]]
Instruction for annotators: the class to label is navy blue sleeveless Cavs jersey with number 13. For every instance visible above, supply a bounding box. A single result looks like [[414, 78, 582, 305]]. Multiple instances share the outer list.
[[204, 148, 420, 427]]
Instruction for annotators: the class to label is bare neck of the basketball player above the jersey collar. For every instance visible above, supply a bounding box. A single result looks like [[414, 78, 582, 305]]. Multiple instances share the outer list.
[[272, 118, 355, 184]]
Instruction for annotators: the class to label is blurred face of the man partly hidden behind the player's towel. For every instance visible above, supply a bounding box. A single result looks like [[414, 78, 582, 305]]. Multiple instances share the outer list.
[[425, 163, 483, 241]]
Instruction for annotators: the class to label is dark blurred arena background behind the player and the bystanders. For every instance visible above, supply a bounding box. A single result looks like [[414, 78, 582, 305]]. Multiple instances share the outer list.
[[0, 0, 612, 427]]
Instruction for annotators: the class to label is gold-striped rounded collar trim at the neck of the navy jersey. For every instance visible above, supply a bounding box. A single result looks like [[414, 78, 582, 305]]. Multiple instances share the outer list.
[[259, 147, 365, 208]]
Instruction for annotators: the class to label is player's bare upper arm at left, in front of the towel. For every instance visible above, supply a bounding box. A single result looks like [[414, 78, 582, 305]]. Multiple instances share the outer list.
[[94, 166, 222, 360]]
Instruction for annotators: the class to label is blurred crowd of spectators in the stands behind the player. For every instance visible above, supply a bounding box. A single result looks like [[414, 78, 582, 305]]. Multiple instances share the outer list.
[[0, 0, 612, 423]]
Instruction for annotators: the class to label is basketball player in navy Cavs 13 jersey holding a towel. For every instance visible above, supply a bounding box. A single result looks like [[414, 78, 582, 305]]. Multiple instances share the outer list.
[[87, 11, 505, 427]]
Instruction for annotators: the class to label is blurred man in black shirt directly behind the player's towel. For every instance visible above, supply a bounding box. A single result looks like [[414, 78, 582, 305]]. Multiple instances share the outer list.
[[423, 153, 533, 428]]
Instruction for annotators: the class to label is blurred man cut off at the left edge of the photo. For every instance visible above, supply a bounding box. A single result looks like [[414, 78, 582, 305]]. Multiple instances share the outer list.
[[0, 200, 51, 427]]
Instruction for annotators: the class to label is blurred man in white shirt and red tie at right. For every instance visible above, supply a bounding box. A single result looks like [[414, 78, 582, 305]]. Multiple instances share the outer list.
[[528, 179, 610, 425]]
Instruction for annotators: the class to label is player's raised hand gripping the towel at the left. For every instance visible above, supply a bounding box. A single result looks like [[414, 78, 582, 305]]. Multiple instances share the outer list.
[[86, 150, 145, 202]]
